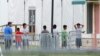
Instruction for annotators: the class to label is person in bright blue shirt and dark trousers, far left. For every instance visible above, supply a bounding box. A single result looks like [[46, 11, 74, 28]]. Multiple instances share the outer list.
[[4, 22, 13, 50]]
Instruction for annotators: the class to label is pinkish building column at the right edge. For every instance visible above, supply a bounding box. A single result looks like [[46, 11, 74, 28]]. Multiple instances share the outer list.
[[93, 3, 100, 47]]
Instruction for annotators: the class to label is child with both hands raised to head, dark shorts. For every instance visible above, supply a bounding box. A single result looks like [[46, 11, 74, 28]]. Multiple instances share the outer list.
[[74, 23, 84, 48]]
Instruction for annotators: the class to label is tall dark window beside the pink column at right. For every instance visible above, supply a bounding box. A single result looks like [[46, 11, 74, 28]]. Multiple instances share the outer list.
[[87, 3, 93, 34]]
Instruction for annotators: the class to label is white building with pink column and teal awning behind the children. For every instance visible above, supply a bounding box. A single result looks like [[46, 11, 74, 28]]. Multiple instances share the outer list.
[[0, 0, 100, 46]]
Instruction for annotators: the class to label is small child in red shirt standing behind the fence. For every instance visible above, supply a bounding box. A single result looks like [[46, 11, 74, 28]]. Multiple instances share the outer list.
[[15, 28, 23, 49]]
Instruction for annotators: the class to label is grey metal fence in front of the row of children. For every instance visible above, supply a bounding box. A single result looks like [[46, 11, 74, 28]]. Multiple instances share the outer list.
[[0, 31, 100, 56]]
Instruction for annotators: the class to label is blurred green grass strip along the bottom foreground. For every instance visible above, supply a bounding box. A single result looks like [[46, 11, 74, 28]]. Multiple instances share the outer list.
[[3, 50, 100, 56]]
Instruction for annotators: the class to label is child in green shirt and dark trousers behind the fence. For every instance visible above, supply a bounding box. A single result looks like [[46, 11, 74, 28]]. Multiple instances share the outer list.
[[61, 25, 68, 48]]
